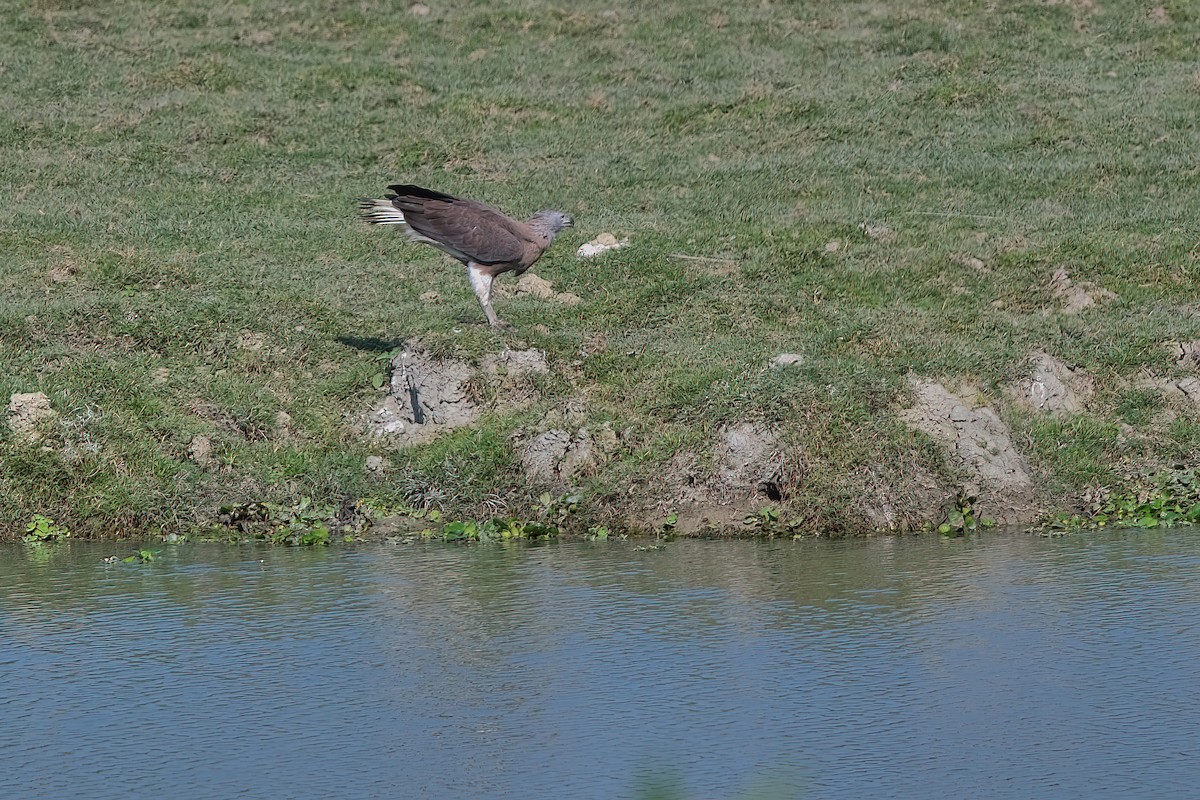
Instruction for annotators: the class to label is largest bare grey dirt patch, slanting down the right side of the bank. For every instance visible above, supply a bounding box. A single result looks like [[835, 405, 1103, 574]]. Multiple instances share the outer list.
[[900, 378, 1036, 523]]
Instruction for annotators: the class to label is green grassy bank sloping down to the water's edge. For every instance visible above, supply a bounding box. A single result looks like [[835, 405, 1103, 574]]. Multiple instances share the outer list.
[[0, 0, 1200, 535]]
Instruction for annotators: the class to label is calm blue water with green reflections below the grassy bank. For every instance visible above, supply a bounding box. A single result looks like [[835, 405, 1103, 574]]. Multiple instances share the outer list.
[[0, 530, 1200, 800]]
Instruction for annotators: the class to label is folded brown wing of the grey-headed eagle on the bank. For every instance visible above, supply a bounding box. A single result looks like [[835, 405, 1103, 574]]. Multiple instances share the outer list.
[[388, 185, 534, 265]]
